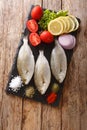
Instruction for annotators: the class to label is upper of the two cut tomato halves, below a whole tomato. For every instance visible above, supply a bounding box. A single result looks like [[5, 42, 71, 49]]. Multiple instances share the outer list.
[[26, 19, 38, 32]]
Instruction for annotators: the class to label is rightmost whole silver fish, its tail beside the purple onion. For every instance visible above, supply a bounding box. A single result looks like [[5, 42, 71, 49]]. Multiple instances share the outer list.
[[50, 39, 67, 83]]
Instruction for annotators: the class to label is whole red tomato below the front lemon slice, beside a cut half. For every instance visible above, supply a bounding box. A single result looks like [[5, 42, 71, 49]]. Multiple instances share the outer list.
[[40, 31, 54, 44]]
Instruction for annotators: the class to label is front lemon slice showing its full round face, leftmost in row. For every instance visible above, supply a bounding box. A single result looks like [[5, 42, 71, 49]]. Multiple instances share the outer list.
[[48, 19, 63, 36]]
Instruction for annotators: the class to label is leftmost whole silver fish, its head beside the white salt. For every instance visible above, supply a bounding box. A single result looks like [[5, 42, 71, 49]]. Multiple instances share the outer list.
[[17, 37, 35, 85]]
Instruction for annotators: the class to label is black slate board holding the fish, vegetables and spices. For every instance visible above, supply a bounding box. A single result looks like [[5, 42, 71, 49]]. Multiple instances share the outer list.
[[6, 5, 79, 106]]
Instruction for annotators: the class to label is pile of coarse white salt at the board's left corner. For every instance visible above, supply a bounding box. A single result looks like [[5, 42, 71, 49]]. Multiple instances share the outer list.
[[9, 76, 22, 92]]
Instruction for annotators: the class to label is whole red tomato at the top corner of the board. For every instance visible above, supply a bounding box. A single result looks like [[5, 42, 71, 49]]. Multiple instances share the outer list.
[[31, 5, 43, 20]]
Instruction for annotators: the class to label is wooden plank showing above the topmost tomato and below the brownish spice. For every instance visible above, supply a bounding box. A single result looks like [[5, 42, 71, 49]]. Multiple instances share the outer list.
[[22, 0, 42, 130]]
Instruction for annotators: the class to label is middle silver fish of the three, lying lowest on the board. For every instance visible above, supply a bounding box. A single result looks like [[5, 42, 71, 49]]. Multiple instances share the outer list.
[[34, 50, 51, 95]]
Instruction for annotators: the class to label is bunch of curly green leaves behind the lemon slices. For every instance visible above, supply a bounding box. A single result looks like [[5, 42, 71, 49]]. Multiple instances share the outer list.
[[38, 9, 68, 30]]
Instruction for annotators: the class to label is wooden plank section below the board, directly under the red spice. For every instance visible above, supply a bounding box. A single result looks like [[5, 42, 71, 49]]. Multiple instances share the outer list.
[[41, 101, 62, 130]]
